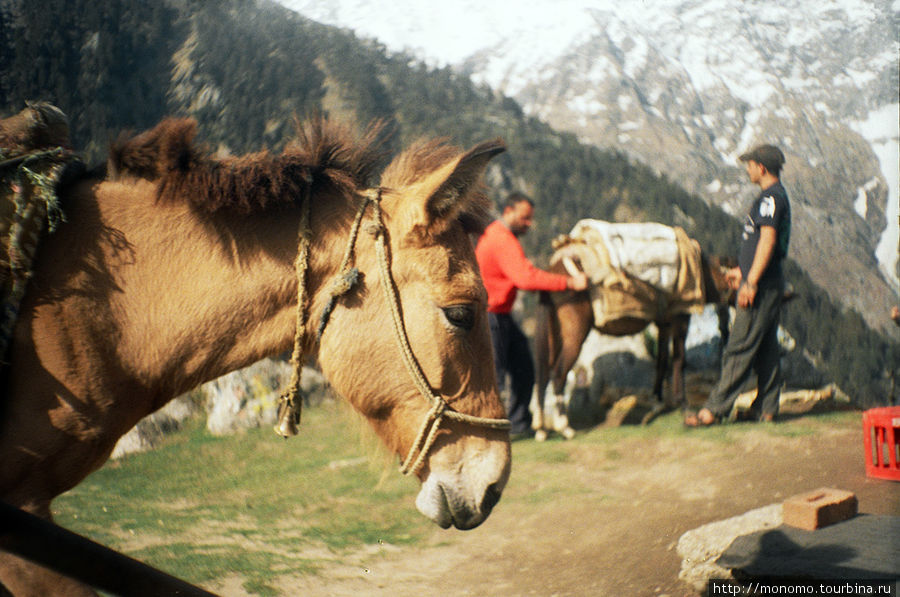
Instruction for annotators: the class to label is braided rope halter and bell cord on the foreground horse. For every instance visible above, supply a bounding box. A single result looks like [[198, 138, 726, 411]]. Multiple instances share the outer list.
[[275, 187, 510, 475]]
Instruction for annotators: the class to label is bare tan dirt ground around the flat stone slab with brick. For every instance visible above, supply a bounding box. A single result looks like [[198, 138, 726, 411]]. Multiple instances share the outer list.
[[255, 417, 900, 597]]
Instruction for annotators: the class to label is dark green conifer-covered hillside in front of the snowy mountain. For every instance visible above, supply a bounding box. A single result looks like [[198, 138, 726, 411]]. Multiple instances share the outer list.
[[0, 0, 900, 406]]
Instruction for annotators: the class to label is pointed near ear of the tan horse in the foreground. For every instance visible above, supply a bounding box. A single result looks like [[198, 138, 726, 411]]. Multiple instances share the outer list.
[[413, 139, 506, 234]]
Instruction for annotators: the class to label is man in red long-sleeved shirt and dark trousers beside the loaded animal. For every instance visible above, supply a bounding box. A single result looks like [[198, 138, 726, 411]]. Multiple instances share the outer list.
[[475, 193, 588, 435]]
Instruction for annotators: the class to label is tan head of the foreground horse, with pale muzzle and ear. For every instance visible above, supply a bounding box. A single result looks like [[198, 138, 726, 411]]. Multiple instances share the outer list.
[[319, 141, 510, 529]]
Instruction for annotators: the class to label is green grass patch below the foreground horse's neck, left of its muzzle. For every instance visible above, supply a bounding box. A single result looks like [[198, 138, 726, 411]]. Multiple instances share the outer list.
[[54, 404, 432, 595]]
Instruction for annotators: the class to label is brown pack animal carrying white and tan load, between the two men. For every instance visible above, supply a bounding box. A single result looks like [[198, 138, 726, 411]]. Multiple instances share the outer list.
[[532, 219, 733, 440]]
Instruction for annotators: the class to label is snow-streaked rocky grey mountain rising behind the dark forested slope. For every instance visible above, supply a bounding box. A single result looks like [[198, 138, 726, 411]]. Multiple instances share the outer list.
[[279, 0, 900, 330]]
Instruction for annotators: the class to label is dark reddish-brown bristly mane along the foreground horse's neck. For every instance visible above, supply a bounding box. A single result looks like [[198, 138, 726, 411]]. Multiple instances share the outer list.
[[108, 117, 383, 212]]
